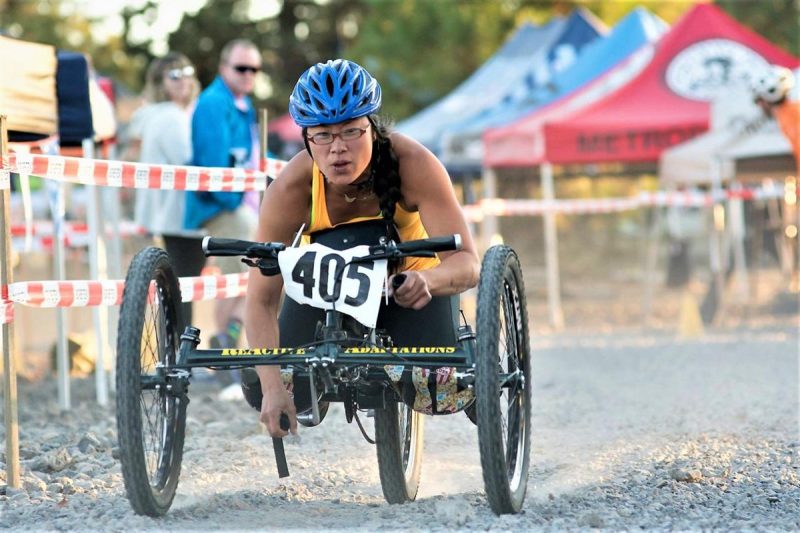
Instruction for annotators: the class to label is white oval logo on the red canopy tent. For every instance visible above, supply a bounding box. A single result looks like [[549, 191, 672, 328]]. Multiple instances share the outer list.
[[666, 39, 768, 101]]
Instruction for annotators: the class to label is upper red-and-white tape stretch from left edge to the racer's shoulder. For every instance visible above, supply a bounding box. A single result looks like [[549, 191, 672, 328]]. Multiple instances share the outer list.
[[4, 154, 286, 192]]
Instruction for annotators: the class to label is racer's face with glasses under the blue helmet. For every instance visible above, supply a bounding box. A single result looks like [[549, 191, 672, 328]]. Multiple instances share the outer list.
[[306, 117, 373, 185]]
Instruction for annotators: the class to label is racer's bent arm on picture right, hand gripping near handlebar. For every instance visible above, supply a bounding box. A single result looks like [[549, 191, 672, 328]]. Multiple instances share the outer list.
[[392, 133, 480, 309]]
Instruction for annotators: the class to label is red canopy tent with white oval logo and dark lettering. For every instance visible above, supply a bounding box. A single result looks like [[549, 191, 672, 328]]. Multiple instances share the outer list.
[[485, 4, 798, 167]]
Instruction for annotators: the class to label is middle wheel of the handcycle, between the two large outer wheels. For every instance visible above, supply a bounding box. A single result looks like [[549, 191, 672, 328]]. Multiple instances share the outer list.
[[375, 402, 425, 503]]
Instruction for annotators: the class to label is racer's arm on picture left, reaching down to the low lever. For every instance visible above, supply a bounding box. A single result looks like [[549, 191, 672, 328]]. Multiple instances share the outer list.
[[244, 153, 311, 437]]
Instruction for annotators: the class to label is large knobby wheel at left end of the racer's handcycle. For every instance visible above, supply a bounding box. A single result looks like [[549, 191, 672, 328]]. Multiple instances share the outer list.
[[117, 248, 188, 516]]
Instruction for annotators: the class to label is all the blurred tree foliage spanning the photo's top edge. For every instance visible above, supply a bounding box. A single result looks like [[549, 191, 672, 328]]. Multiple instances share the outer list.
[[0, 0, 800, 119]]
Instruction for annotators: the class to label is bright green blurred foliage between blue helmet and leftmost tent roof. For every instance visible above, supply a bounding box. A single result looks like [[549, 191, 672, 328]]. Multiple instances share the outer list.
[[345, 0, 553, 119]]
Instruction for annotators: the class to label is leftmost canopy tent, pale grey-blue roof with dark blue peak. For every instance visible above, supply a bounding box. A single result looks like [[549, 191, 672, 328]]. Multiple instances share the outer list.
[[397, 9, 603, 153]]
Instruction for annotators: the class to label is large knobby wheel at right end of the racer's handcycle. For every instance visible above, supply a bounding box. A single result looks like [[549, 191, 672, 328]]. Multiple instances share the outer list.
[[475, 246, 533, 514]]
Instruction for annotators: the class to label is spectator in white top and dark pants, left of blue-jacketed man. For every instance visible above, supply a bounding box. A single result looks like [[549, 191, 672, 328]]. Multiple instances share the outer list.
[[130, 52, 205, 331]]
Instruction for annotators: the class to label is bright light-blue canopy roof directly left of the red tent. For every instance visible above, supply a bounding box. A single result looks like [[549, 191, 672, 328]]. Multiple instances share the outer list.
[[440, 7, 668, 173]]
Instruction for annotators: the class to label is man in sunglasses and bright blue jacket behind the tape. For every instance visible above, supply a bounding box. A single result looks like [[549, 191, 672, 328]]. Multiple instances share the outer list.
[[184, 39, 261, 381]]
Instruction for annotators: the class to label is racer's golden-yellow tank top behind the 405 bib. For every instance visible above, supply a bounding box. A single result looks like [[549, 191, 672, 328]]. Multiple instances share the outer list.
[[304, 163, 440, 270]]
